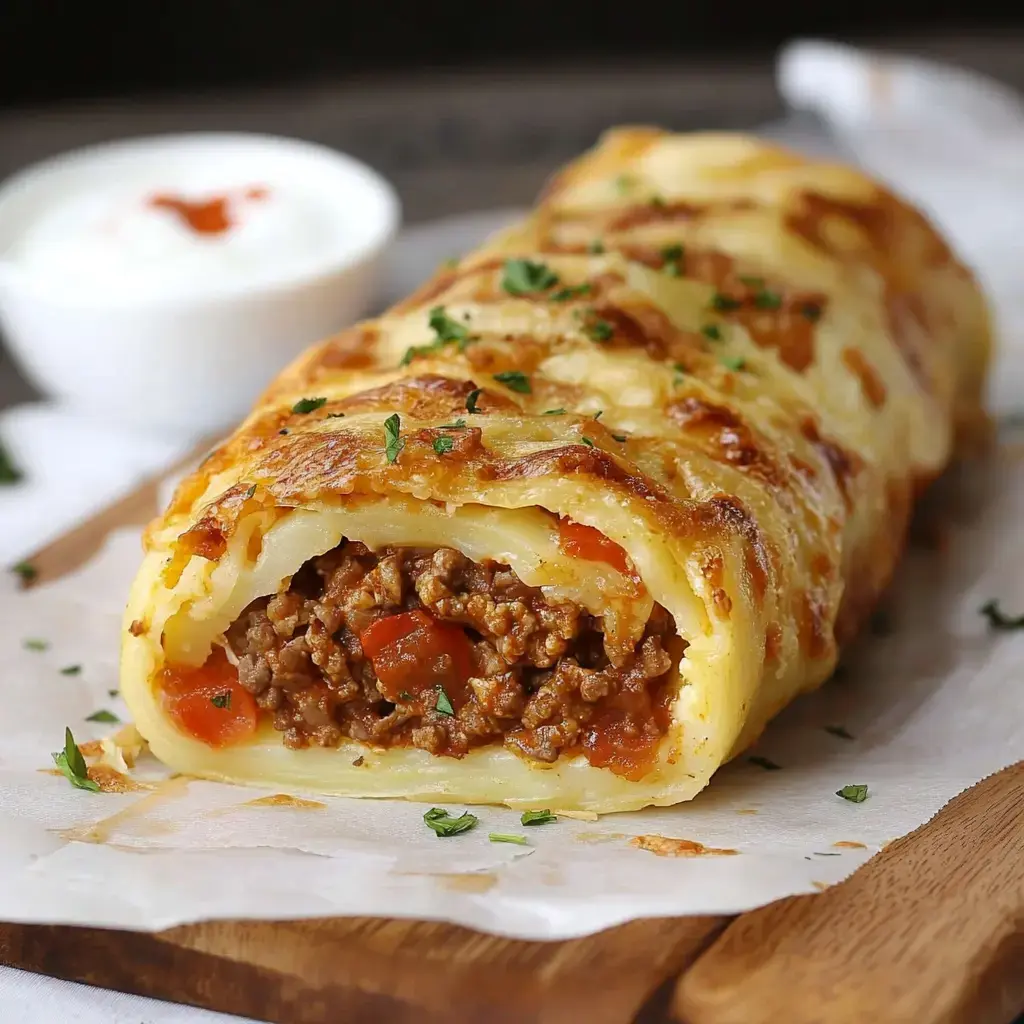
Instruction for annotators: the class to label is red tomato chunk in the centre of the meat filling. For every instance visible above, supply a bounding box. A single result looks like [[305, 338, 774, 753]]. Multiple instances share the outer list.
[[359, 609, 473, 708]]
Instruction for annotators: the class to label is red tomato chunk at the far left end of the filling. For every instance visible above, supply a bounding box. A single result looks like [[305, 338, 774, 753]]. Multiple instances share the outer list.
[[159, 647, 258, 746]]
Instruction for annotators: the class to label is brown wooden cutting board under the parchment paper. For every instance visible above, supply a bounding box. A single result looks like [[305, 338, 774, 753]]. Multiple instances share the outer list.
[[0, 466, 1024, 1024]]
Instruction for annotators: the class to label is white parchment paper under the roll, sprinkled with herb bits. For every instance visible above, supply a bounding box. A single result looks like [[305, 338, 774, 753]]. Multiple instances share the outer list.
[[0, 39, 1024, 939]]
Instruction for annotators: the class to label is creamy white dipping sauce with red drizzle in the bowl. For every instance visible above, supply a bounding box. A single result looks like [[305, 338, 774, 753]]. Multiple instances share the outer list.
[[3, 135, 372, 301]]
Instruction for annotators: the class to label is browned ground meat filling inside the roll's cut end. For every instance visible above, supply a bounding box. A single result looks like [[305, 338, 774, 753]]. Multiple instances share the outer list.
[[227, 541, 684, 776]]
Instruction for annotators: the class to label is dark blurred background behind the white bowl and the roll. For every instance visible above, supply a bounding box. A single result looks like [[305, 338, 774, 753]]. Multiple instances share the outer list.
[[0, 0, 1024, 407]]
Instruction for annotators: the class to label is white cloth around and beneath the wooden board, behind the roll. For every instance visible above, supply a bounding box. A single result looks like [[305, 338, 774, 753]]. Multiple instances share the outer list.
[[0, 36, 1024, 1024]]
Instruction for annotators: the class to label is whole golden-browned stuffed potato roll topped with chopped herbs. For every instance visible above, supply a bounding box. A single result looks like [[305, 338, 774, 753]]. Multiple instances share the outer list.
[[121, 128, 989, 812]]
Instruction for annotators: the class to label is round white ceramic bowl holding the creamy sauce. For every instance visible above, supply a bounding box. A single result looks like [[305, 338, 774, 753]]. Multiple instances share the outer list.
[[0, 133, 400, 435]]
